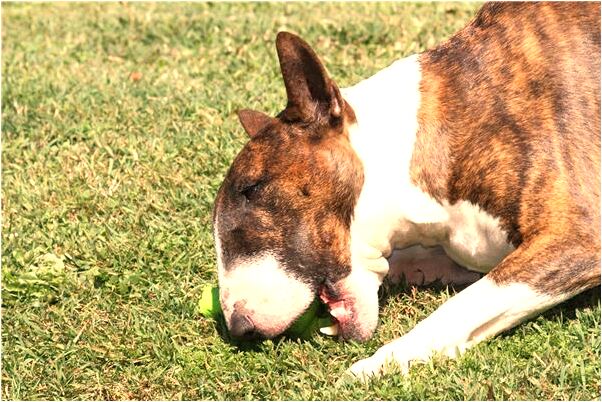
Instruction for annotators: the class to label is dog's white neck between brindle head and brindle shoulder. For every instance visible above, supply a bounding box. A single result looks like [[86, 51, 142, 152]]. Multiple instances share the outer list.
[[342, 55, 448, 272]]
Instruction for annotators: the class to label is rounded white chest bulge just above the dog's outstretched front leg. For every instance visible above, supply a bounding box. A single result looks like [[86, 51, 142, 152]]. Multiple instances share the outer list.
[[441, 201, 514, 272]]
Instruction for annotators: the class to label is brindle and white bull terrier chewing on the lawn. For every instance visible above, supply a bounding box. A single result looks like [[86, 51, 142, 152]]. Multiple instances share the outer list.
[[213, 3, 600, 378]]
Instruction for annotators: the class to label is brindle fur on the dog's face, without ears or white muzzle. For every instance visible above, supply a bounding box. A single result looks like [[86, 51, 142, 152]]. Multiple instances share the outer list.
[[216, 115, 363, 282]]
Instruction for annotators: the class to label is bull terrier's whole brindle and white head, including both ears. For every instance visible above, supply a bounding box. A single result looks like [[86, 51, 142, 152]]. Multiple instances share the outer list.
[[214, 32, 378, 340]]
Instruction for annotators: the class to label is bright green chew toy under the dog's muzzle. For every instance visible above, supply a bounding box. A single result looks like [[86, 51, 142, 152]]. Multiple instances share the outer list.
[[197, 284, 332, 339]]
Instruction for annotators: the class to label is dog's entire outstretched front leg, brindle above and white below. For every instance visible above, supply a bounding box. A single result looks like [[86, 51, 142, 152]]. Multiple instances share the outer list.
[[349, 240, 600, 379]]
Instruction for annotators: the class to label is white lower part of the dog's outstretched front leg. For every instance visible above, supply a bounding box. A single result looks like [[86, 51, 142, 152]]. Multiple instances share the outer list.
[[350, 278, 568, 378]]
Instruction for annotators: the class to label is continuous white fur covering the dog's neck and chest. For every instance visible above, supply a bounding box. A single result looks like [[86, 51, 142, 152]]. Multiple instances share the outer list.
[[342, 56, 514, 279]]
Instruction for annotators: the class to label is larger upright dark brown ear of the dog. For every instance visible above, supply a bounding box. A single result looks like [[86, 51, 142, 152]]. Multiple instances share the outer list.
[[276, 32, 344, 122]]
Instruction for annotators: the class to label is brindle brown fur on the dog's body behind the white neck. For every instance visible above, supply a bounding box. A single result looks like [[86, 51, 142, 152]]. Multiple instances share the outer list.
[[411, 3, 600, 291]]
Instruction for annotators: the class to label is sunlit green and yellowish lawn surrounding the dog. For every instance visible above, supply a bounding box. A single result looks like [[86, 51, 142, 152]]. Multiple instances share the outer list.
[[2, 3, 600, 400]]
